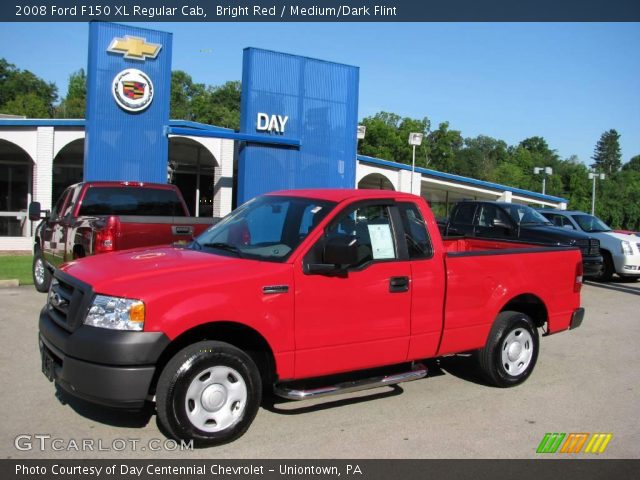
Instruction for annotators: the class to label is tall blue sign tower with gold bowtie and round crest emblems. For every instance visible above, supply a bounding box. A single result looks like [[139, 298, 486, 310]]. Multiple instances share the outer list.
[[84, 22, 172, 183]]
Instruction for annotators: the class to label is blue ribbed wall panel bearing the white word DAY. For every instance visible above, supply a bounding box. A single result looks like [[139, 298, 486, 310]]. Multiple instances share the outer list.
[[238, 48, 359, 204]]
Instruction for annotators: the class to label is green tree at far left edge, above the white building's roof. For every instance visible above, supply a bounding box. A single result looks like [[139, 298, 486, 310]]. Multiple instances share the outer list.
[[0, 58, 58, 118]]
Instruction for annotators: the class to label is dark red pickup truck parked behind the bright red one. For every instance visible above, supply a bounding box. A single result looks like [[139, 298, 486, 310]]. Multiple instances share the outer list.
[[29, 182, 215, 292]]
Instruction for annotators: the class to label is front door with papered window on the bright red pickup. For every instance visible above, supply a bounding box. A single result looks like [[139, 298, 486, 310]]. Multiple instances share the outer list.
[[295, 201, 411, 378]]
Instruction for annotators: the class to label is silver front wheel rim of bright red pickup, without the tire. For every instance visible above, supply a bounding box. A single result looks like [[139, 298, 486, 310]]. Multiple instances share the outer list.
[[184, 366, 248, 432]]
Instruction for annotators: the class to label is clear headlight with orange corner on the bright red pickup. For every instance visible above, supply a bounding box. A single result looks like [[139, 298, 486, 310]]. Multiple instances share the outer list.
[[84, 295, 144, 331]]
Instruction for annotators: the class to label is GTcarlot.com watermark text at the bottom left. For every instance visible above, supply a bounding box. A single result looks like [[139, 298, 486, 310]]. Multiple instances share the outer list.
[[13, 433, 193, 452]]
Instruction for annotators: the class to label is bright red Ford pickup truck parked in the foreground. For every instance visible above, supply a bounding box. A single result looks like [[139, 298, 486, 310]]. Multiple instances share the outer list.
[[39, 190, 584, 446]]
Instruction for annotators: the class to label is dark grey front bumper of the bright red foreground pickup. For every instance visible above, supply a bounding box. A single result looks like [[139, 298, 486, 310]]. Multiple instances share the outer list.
[[38, 307, 169, 409]]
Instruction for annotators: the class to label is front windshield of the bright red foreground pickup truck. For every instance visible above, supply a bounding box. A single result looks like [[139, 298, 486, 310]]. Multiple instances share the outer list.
[[189, 195, 335, 262]]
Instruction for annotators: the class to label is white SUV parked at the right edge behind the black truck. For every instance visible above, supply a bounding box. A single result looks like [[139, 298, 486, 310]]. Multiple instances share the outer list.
[[539, 209, 640, 281]]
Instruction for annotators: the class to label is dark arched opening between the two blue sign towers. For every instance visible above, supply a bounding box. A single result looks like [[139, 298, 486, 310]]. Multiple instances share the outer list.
[[168, 136, 219, 217]]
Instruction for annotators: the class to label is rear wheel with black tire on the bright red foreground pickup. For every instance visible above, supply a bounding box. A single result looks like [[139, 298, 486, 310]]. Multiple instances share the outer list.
[[478, 311, 540, 387]]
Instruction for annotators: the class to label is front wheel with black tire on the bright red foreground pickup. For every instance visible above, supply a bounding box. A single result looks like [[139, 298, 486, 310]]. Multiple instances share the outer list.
[[156, 341, 262, 447]]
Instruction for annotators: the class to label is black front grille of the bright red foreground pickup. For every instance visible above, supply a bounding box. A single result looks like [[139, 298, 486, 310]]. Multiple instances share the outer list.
[[47, 272, 91, 332]]
